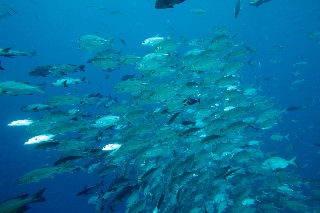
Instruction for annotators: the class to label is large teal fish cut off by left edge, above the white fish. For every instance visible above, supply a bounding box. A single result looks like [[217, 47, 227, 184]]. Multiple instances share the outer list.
[[0, 81, 45, 96]]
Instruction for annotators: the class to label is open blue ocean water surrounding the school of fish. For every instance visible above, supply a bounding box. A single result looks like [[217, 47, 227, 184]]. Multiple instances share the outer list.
[[0, 0, 320, 213]]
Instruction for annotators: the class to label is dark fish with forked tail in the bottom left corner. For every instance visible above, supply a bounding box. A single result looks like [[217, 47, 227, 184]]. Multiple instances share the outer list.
[[0, 188, 46, 213]]
